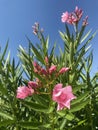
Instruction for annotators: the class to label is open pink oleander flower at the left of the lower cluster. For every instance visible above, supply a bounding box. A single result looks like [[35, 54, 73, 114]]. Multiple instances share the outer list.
[[16, 86, 34, 99]]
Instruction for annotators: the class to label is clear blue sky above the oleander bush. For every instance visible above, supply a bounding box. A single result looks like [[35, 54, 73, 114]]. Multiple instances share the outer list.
[[0, 0, 98, 73]]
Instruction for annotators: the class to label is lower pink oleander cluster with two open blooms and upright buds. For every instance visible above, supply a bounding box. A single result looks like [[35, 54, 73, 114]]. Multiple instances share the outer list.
[[16, 57, 76, 110]]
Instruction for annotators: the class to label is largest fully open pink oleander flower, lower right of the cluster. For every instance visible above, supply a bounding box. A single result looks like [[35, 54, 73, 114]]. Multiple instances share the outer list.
[[52, 83, 76, 111]]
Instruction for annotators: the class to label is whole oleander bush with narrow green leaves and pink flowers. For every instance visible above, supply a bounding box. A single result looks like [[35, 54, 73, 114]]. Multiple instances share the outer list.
[[0, 3, 95, 130]]
